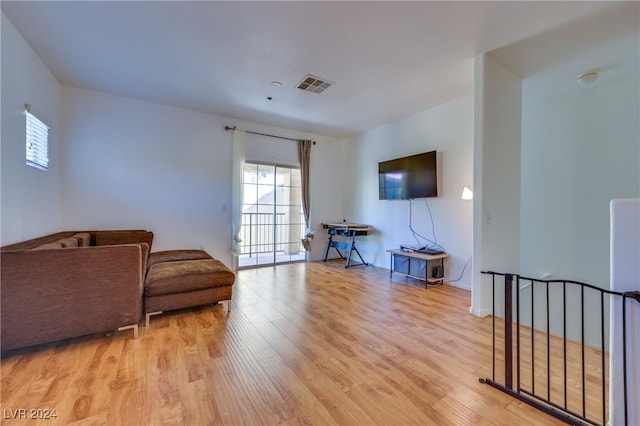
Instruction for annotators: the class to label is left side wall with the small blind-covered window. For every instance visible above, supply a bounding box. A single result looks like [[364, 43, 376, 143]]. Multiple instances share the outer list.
[[0, 13, 62, 245]]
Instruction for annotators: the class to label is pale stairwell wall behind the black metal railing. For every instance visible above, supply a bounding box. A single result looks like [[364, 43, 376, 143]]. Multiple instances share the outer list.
[[519, 37, 640, 347]]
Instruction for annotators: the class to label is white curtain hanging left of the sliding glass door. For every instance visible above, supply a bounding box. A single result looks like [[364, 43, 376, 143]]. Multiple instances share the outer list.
[[231, 129, 247, 263]]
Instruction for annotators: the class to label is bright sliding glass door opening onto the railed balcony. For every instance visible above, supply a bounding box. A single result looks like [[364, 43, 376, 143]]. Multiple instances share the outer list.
[[238, 163, 306, 268]]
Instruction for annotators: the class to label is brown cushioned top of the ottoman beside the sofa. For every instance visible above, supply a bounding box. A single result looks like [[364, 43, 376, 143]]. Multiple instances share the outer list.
[[144, 259, 235, 296]]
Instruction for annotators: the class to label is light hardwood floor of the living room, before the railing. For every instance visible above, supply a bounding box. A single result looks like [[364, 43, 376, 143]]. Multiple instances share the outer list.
[[1, 261, 560, 425]]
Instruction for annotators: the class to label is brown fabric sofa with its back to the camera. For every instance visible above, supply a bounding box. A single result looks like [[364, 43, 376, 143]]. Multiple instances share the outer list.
[[0, 230, 153, 351]]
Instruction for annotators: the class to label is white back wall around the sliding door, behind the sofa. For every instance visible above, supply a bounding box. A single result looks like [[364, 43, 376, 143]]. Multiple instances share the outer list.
[[62, 87, 342, 264]]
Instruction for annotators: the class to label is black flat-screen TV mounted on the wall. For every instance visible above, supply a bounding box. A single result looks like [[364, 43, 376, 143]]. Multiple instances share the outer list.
[[378, 151, 438, 200]]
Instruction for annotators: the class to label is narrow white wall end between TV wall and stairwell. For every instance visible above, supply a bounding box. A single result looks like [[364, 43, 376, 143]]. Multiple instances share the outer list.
[[471, 55, 521, 316]]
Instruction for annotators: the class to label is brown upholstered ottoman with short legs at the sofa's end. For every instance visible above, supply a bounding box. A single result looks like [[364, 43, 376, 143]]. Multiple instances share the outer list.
[[144, 250, 236, 327]]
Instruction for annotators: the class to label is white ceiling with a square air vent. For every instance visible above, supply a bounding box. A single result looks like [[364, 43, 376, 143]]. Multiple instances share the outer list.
[[2, 0, 638, 137]]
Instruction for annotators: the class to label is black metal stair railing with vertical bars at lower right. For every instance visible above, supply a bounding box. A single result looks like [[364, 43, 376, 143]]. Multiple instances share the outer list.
[[480, 271, 640, 425]]
